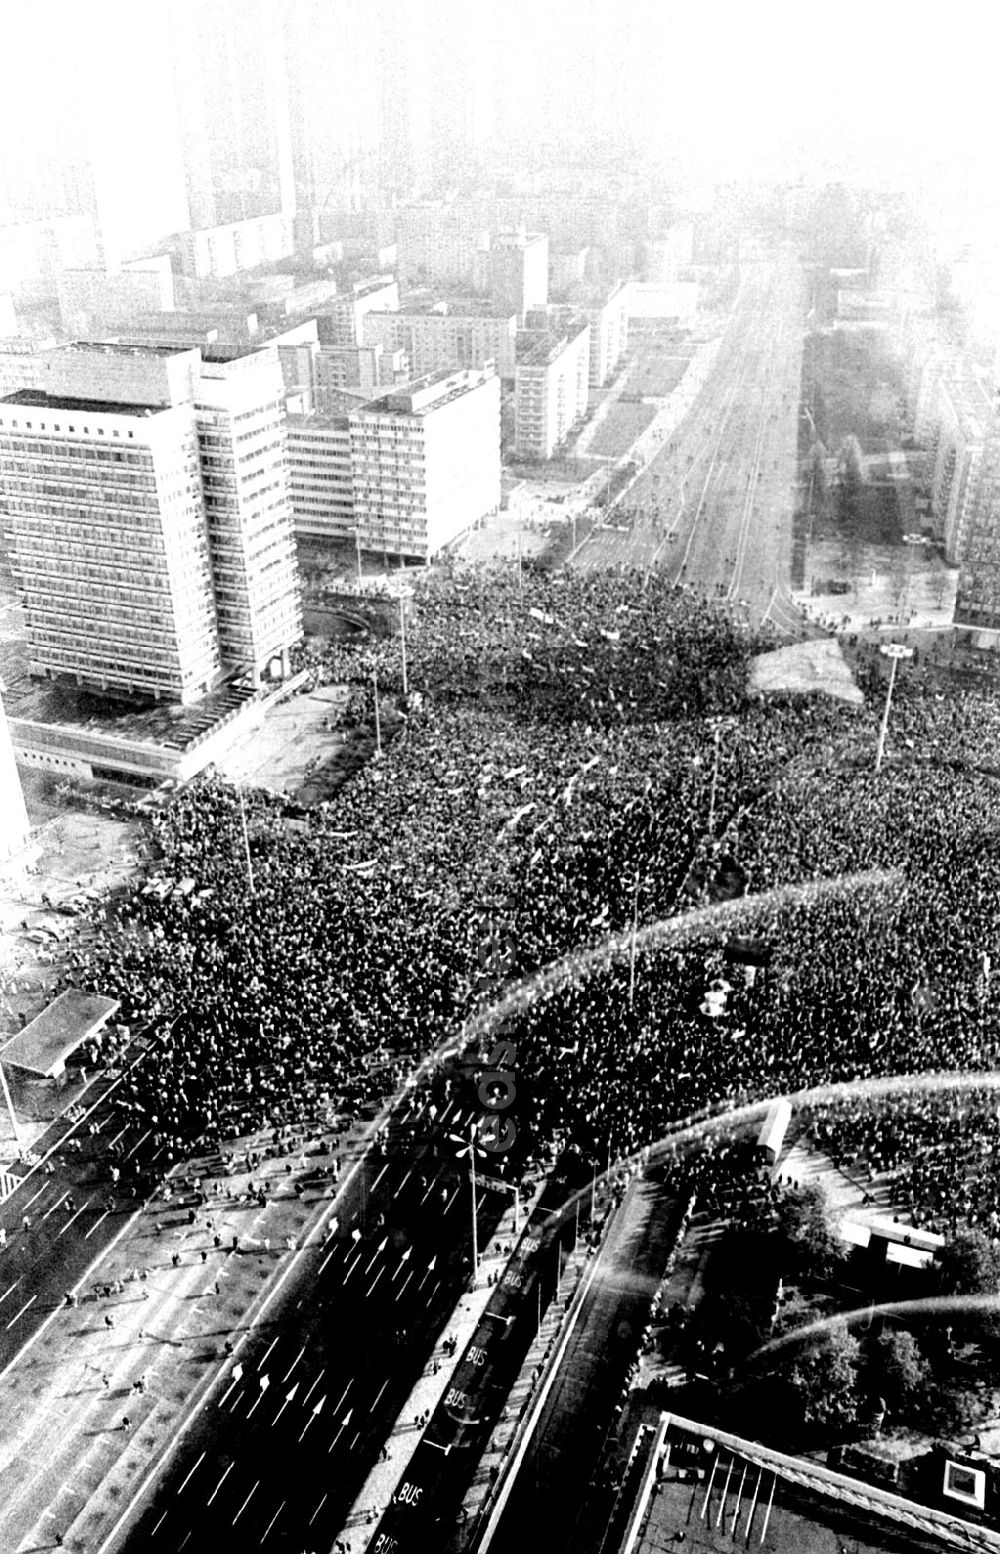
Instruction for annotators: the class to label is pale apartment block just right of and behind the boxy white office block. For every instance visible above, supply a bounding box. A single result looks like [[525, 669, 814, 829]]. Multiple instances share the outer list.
[[514, 319, 590, 458]]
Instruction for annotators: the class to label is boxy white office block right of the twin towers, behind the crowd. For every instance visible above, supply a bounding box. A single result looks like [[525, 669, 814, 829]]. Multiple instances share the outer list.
[[349, 368, 500, 559]]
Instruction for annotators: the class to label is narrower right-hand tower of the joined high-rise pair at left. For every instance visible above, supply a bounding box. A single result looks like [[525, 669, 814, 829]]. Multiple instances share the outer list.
[[196, 348, 301, 673]]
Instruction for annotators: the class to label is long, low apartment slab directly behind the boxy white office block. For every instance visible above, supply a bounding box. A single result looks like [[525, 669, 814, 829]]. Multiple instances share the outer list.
[[363, 301, 517, 382]]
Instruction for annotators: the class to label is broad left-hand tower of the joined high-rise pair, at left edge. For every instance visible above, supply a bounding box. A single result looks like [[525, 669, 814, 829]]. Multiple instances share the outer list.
[[0, 347, 219, 702]]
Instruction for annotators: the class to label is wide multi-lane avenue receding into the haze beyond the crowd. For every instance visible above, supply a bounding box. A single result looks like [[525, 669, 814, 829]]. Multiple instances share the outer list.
[[575, 249, 804, 625]]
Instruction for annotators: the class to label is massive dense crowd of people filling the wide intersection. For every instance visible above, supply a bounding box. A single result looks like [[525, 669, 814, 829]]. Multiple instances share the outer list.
[[54, 566, 1000, 1230]]
